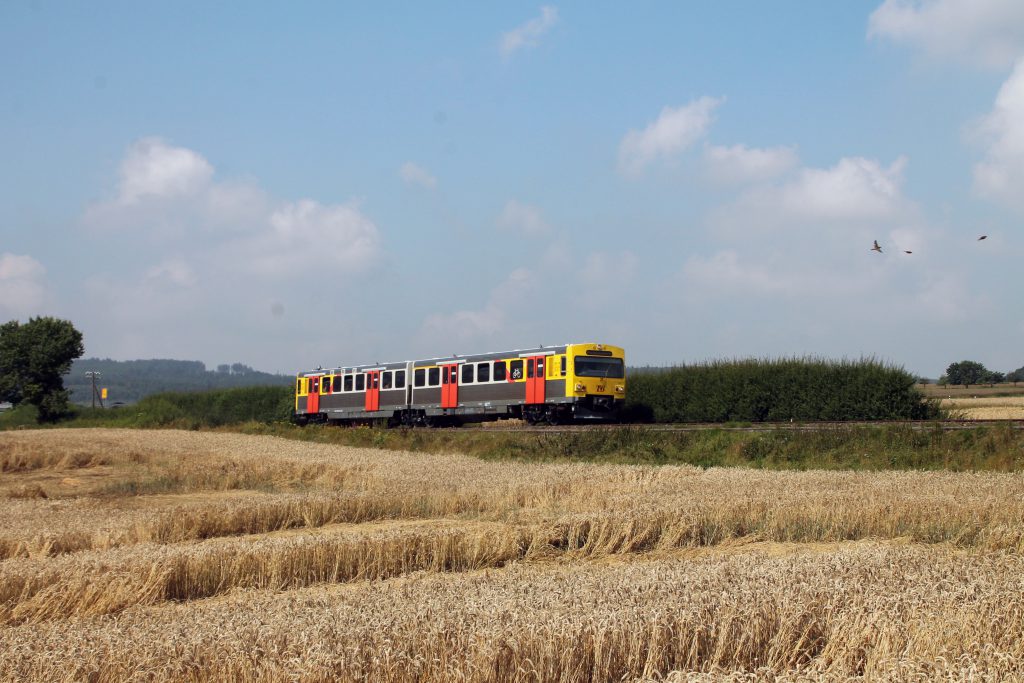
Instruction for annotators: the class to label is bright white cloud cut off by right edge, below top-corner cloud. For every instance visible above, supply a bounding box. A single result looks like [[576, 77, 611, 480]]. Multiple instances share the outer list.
[[974, 57, 1024, 212]]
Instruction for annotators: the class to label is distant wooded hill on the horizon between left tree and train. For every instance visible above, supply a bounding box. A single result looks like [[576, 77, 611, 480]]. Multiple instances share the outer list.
[[65, 358, 295, 405]]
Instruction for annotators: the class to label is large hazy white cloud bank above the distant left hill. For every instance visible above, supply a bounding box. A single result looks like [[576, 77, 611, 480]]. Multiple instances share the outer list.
[[73, 137, 382, 371]]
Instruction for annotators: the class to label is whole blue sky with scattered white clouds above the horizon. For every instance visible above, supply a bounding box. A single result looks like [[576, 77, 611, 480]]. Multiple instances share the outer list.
[[0, 0, 1024, 377]]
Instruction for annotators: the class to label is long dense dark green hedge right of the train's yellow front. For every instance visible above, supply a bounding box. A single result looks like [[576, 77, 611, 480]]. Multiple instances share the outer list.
[[627, 357, 939, 423]]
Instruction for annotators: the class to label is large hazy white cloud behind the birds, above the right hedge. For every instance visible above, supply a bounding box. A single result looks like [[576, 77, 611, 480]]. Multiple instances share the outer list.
[[675, 145, 989, 335]]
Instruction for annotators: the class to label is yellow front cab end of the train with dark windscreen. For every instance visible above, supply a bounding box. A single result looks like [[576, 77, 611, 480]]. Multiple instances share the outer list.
[[565, 344, 626, 422]]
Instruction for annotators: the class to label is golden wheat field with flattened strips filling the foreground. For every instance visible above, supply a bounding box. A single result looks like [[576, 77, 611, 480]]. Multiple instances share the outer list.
[[0, 429, 1024, 682]]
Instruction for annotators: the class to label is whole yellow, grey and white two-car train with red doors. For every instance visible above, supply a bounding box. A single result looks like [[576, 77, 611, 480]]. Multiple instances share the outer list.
[[293, 343, 626, 427]]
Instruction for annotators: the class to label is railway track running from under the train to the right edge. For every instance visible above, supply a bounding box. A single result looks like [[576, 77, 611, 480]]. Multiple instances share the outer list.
[[462, 420, 1024, 434]]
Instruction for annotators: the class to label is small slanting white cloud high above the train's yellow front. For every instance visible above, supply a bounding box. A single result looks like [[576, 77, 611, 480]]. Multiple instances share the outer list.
[[618, 96, 724, 174]]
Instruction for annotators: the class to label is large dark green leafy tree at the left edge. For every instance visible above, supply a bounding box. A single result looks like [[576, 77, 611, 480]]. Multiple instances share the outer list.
[[0, 317, 85, 422]]
